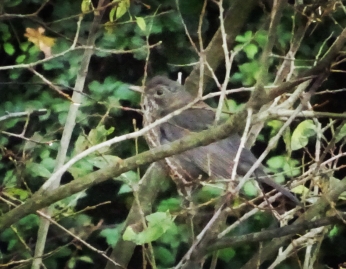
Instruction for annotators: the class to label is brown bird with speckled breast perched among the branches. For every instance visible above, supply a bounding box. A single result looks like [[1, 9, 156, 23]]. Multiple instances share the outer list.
[[135, 76, 301, 205]]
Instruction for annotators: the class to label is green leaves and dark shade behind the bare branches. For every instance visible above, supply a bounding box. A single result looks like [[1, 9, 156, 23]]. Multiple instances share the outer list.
[[0, 0, 346, 269]]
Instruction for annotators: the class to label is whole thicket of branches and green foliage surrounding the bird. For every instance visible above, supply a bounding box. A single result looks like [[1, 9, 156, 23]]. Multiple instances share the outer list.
[[0, 0, 346, 269]]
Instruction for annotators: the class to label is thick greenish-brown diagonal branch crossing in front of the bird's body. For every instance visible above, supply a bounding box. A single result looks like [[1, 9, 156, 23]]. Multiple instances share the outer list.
[[0, 44, 346, 230]]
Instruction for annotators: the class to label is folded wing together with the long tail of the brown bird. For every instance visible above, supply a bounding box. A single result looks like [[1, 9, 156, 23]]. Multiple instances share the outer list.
[[161, 109, 300, 205]]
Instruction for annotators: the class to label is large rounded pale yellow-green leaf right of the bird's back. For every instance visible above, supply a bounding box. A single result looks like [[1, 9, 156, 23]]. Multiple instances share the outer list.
[[291, 120, 316, 150]]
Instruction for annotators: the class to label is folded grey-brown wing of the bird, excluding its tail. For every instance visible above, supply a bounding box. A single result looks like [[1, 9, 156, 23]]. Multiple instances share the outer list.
[[161, 102, 257, 178]]
